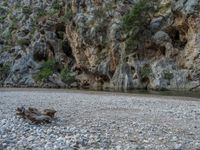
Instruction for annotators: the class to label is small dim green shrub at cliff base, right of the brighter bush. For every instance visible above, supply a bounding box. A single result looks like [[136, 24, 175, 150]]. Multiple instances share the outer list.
[[61, 68, 75, 84]]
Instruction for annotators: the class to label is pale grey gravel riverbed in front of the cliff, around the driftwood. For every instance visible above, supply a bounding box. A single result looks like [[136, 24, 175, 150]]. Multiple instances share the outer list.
[[0, 89, 200, 150]]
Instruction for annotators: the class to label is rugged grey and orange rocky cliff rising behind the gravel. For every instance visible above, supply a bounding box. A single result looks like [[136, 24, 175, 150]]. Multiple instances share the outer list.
[[0, 0, 200, 90]]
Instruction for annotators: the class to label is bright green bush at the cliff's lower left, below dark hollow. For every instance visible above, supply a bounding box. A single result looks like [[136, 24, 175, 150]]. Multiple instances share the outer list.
[[34, 60, 56, 81]]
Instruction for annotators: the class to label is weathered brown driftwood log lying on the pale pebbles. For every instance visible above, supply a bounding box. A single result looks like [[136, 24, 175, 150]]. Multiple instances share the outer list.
[[16, 107, 56, 124]]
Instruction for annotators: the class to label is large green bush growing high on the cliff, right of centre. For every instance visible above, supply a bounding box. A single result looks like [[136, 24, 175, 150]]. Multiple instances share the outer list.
[[122, 0, 158, 51]]
